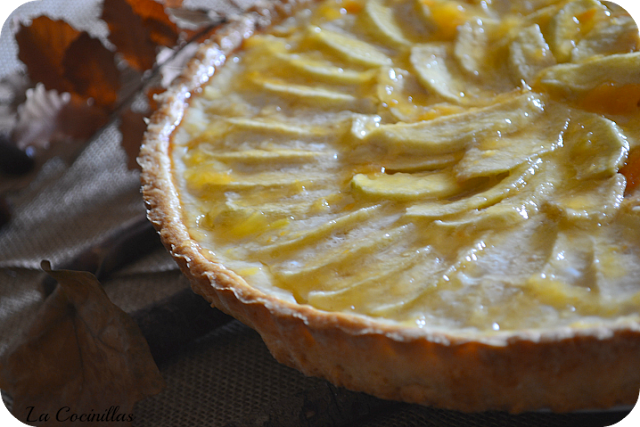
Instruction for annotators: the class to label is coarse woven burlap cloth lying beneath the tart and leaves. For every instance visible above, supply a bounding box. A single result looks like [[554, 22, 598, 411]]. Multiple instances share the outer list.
[[0, 0, 636, 427]]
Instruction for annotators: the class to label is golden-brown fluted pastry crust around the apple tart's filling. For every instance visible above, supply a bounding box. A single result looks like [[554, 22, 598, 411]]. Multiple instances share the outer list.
[[139, 0, 640, 412]]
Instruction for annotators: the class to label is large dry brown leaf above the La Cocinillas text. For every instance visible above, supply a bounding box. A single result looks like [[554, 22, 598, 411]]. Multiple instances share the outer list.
[[0, 261, 164, 426]]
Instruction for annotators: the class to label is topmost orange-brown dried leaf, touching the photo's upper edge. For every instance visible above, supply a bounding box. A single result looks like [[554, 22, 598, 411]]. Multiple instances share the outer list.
[[102, 0, 179, 71]]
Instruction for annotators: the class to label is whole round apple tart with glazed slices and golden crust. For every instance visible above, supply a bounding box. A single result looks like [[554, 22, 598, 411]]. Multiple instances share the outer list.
[[139, 0, 640, 412]]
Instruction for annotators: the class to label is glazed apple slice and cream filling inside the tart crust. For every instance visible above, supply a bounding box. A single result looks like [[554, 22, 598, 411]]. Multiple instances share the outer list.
[[172, 0, 640, 333]]
